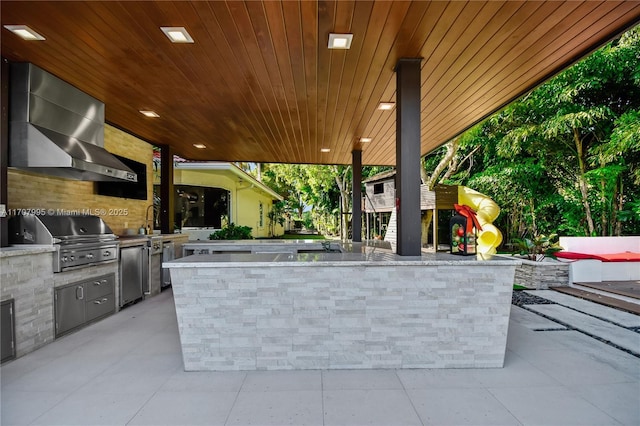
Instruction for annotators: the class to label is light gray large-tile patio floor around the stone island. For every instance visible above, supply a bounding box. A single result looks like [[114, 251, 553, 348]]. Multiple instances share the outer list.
[[0, 291, 640, 426]]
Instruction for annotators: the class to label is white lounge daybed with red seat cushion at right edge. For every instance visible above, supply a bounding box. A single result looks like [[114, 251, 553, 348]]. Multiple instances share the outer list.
[[556, 236, 640, 284]]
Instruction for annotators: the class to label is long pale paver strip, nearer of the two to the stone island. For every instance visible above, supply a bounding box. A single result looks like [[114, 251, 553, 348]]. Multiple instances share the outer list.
[[527, 305, 640, 356]]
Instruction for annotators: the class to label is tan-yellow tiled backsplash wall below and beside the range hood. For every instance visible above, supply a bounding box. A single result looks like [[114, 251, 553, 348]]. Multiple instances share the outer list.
[[7, 125, 153, 235]]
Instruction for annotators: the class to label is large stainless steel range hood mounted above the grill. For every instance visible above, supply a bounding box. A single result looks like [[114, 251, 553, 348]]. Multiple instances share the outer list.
[[9, 63, 137, 182]]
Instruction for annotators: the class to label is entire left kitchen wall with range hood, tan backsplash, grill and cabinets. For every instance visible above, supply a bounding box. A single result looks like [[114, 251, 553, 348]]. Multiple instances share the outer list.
[[0, 63, 187, 362]]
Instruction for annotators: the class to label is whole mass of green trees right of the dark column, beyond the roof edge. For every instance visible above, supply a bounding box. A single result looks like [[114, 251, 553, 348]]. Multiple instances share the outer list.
[[422, 28, 640, 240]]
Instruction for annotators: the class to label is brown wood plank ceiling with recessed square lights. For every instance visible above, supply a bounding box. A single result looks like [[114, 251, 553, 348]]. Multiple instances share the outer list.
[[0, 0, 640, 165]]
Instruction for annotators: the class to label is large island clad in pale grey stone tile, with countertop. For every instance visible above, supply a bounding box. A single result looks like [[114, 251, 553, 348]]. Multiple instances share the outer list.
[[163, 244, 519, 371]]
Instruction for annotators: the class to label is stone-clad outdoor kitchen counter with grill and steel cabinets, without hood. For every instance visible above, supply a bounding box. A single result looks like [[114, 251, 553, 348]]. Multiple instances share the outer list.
[[0, 221, 186, 360]]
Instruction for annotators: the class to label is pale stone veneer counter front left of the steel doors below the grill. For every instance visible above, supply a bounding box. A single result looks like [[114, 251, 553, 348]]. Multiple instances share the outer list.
[[0, 252, 55, 357]]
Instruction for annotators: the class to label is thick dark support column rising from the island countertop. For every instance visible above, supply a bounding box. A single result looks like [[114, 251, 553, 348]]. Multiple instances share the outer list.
[[396, 58, 422, 256]]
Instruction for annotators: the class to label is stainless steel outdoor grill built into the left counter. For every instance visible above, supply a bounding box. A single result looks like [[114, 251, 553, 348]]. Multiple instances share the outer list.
[[9, 214, 119, 272]]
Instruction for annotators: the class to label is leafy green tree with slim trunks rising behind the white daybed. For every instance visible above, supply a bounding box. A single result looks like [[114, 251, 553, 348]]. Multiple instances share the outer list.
[[478, 28, 640, 235]]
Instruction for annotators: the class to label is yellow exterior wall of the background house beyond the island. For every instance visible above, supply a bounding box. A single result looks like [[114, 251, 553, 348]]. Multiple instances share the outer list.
[[168, 169, 284, 238]]
